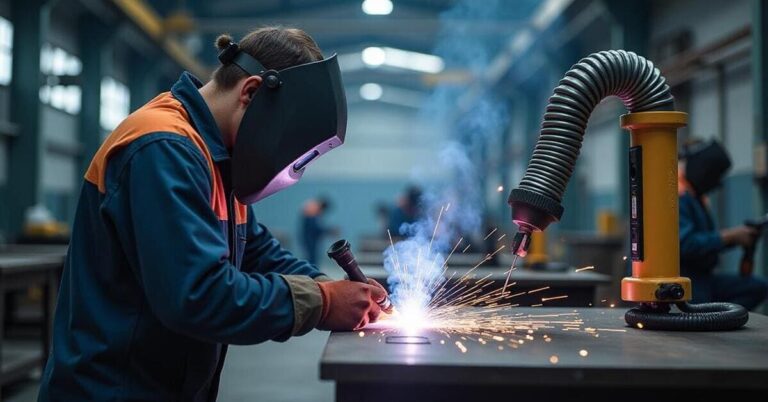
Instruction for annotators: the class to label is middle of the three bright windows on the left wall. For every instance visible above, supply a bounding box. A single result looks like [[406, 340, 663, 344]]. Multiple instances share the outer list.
[[40, 44, 83, 114]]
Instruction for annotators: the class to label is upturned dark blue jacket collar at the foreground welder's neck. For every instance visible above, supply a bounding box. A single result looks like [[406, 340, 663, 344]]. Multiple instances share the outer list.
[[171, 71, 230, 162]]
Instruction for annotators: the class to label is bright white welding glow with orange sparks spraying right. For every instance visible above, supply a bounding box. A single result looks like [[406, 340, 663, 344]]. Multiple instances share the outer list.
[[380, 205, 585, 353]]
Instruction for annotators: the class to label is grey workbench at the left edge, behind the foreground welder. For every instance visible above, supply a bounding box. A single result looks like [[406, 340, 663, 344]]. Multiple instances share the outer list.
[[0, 247, 64, 398]]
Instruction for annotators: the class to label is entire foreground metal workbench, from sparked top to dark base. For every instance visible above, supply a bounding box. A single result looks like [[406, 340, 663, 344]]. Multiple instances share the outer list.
[[320, 307, 768, 402]]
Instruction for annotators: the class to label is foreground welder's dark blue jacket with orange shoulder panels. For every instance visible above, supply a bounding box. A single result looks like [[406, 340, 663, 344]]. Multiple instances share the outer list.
[[39, 73, 327, 402]]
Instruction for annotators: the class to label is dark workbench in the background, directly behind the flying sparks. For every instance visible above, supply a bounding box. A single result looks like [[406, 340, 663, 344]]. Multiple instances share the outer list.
[[360, 265, 619, 307]]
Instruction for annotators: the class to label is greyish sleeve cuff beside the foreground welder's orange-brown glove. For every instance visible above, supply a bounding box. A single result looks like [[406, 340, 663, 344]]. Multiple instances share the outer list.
[[280, 275, 330, 336]]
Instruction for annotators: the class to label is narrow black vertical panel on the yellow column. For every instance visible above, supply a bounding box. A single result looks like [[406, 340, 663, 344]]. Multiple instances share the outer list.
[[629, 147, 643, 261]]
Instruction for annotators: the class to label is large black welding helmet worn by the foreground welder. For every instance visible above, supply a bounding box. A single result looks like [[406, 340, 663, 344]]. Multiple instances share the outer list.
[[219, 43, 347, 204]]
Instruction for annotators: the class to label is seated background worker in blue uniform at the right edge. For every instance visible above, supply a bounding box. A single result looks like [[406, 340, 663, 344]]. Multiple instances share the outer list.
[[678, 141, 768, 310]]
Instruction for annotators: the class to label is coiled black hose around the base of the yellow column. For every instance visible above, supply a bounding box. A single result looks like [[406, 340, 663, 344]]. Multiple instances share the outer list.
[[624, 303, 749, 331]]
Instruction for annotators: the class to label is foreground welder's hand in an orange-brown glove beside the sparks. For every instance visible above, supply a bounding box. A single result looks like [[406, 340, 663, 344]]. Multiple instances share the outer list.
[[317, 281, 387, 331]]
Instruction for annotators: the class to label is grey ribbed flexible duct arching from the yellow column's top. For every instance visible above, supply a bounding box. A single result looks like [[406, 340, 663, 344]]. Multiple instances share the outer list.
[[510, 50, 674, 219]]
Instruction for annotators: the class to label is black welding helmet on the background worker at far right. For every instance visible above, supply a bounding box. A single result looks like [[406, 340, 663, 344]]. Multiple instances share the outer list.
[[680, 140, 731, 195]]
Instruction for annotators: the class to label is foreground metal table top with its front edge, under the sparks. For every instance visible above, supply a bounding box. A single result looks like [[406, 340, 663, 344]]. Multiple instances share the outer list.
[[320, 307, 768, 388]]
